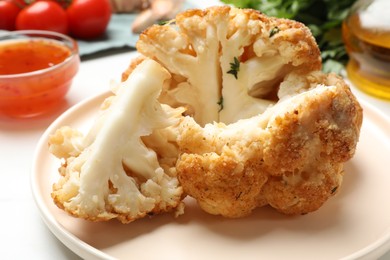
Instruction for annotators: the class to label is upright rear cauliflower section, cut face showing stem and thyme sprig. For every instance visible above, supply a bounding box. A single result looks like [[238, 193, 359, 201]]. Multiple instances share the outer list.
[[137, 6, 321, 125]]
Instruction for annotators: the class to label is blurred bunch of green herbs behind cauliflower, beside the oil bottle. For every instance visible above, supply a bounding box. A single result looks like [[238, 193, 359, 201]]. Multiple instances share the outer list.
[[222, 0, 356, 73]]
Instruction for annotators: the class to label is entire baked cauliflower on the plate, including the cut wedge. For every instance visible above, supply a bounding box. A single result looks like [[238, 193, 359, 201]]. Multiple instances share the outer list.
[[49, 6, 362, 223]]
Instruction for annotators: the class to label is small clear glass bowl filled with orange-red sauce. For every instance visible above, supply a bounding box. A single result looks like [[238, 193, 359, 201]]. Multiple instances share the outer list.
[[0, 30, 80, 118]]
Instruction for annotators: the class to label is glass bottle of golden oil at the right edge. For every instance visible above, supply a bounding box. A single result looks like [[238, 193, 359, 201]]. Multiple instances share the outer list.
[[342, 0, 390, 100]]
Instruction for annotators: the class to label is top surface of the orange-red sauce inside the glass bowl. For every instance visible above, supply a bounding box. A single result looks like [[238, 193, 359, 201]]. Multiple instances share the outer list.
[[0, 40, 71, 75]]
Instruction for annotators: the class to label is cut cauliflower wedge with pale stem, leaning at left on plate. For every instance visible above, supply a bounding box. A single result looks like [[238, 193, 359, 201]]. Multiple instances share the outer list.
[[49, 60, 183, 223]]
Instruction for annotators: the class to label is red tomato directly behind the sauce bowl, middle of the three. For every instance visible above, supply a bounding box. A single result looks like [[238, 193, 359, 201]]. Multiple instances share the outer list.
[[16, 1, 68, 34]]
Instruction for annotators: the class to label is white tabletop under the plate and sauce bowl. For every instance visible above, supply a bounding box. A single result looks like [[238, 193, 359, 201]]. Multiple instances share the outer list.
[[0, 49, 390, 260]]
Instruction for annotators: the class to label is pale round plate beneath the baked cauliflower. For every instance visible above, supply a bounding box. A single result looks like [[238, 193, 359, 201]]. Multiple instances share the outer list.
[[32, 93, 390, 260]]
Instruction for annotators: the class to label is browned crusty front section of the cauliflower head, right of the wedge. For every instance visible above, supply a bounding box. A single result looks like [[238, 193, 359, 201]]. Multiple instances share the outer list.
[[176, 72, 362, 218]]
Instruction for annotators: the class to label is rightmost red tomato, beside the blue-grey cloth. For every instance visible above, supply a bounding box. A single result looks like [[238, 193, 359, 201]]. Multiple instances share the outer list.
[[66, 0, 111, 39]]
